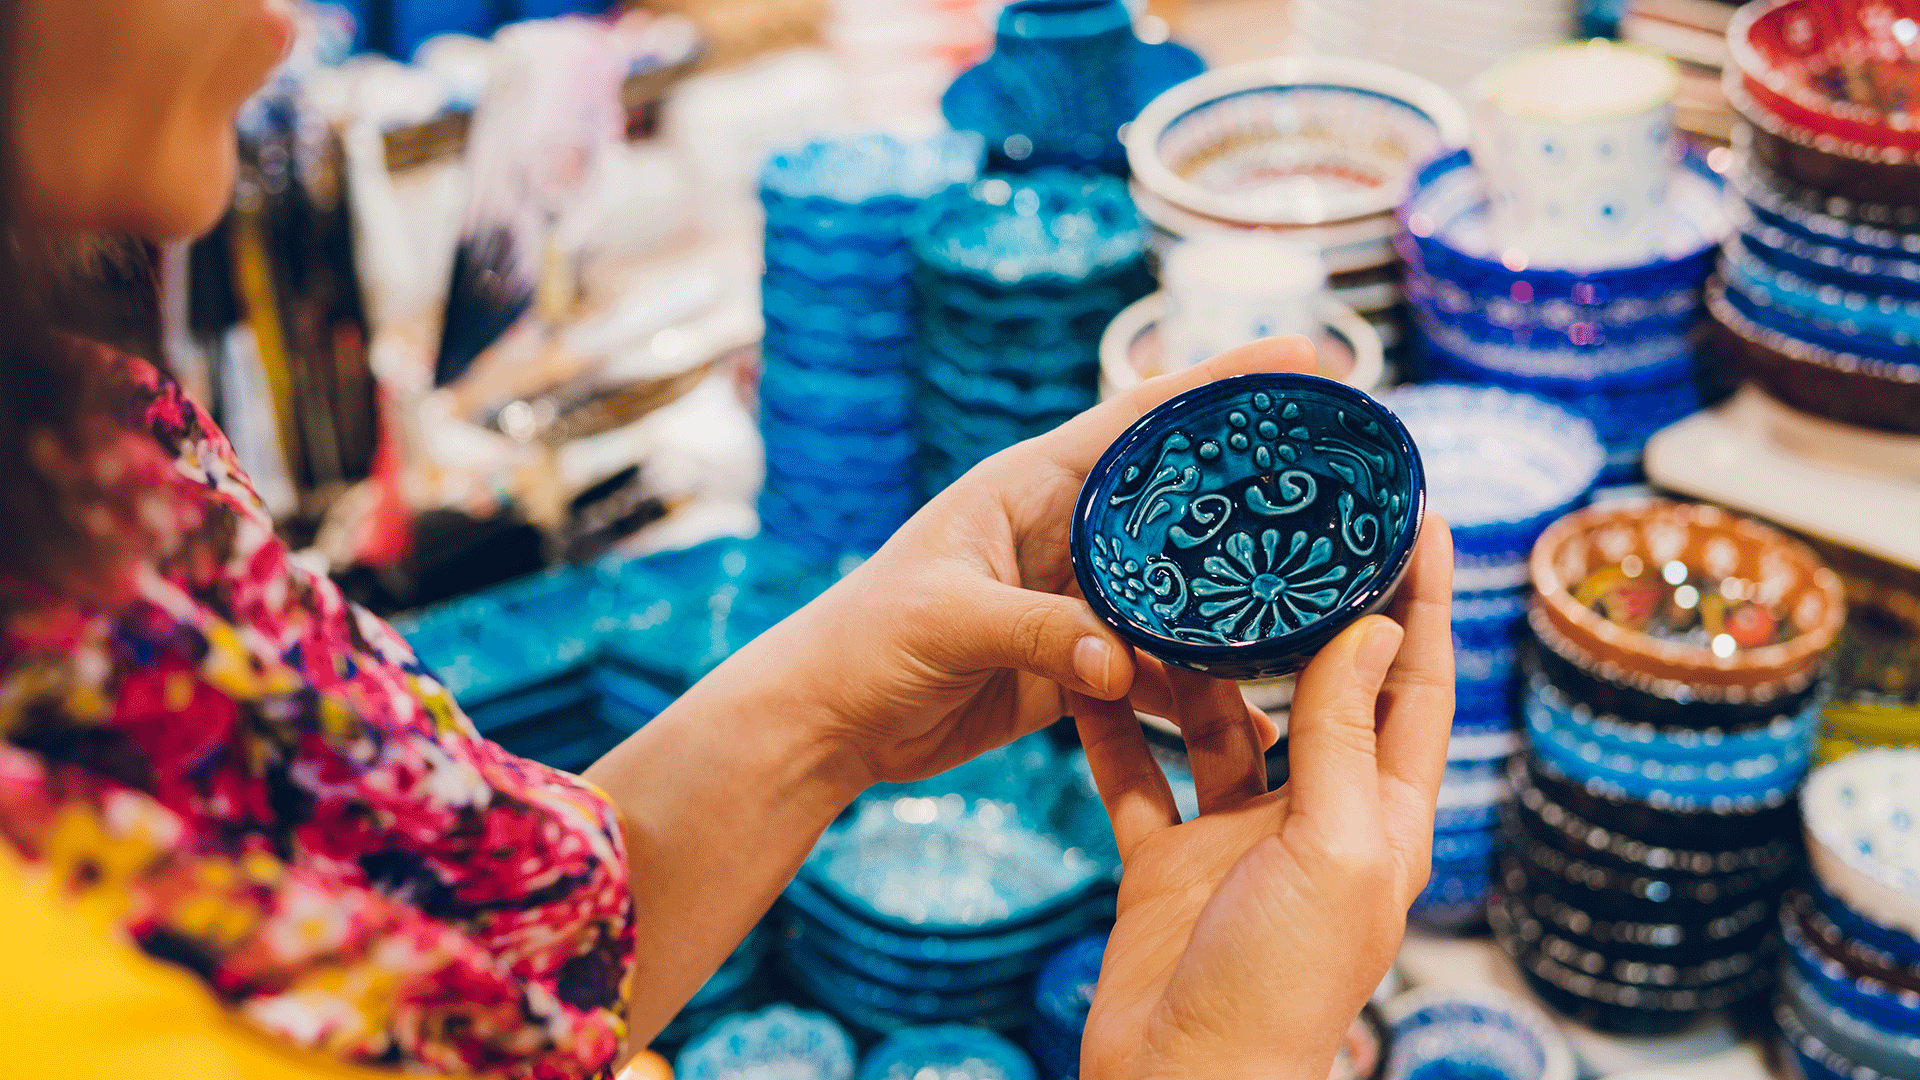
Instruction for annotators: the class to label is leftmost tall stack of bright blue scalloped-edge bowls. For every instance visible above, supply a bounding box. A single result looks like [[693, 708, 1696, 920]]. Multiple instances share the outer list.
[[760, 135, 981, 557]]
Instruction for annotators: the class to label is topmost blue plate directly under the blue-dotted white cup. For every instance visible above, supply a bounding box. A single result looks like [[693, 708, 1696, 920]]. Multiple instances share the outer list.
[[1396, 150, 1728, 304]]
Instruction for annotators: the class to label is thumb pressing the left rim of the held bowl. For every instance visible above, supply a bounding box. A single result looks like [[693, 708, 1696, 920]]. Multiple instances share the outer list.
[[943, 580, 1133, 701]]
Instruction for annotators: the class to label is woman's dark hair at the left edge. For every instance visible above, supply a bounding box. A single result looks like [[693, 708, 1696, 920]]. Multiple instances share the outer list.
[[0, 0, 157, 588]]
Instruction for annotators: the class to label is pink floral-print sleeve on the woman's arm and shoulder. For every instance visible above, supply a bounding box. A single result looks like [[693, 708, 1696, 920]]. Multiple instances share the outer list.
[[0, 350, 634, 1080]]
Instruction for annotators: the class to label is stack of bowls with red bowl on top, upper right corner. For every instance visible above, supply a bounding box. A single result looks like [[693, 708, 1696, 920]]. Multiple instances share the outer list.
[[1709, 0, 1920, 445]]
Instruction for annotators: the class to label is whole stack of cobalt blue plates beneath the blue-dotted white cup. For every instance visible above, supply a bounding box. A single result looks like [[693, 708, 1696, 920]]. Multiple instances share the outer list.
[[1396, 152, 1726, 484]]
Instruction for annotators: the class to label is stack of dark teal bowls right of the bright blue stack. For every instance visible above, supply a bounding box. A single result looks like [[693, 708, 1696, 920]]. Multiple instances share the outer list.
[[908, 171, 1152, 498]]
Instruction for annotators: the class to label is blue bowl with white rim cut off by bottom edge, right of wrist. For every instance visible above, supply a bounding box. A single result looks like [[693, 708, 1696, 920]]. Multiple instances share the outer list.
[[1386, 988, 1574, 1080]]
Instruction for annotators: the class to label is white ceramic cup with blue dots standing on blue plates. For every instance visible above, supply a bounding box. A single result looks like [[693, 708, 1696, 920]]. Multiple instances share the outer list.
[[1471, 40, 1680, 269]]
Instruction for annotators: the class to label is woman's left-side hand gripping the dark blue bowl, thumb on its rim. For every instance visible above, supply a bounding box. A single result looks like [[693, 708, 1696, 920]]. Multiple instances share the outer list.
[[764, 338, 1313, 780]]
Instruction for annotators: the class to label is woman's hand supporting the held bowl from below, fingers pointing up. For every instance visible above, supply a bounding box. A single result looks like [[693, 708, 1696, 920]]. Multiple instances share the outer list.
[[1071, 515, 1453, 1080]]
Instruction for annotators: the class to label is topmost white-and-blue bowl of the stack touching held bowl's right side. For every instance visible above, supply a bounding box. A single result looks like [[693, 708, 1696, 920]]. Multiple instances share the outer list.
[[1380, 384, 1605, 553]]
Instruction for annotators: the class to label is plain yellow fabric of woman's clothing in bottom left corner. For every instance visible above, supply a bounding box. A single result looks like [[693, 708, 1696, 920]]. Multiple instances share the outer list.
[[0, 842, 462, 1080]]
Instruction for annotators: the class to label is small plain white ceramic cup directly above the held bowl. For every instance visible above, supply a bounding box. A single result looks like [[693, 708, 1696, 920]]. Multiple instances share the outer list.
[[1160, 233, 1327, 371]]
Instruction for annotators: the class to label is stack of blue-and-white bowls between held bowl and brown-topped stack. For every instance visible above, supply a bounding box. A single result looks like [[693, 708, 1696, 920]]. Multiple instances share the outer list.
[[1380, 384, 1605, 928]]
